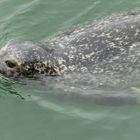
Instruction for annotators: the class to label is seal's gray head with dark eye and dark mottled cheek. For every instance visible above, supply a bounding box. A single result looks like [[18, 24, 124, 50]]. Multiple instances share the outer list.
[[0, 42, 58, 77]]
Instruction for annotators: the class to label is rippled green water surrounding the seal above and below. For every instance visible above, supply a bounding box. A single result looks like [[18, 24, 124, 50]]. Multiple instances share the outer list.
[[0, 0, 140, 140]]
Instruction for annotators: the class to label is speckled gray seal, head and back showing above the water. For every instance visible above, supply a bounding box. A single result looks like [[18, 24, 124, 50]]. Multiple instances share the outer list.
[[0, 14, 140, 77]]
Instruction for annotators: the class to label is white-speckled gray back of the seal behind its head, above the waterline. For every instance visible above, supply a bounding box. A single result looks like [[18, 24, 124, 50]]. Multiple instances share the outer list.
[[48, 14, 140, 77]]
